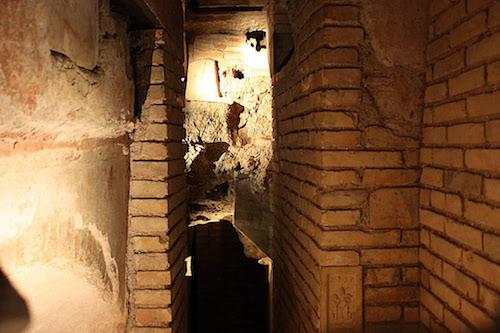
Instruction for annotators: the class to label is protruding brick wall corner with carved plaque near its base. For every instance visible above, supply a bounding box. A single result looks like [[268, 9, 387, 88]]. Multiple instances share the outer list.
[[271, 0, 427, 332]]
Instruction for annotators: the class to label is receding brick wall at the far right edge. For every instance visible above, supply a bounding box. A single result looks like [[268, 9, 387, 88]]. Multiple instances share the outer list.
[[420, 0, 500, 332]]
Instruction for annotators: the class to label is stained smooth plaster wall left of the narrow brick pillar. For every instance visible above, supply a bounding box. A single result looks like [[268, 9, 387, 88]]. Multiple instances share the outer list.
[[0, 0, 133, 332]]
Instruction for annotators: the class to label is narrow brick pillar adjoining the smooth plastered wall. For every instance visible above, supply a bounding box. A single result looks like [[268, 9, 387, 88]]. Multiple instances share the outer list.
[[128, 26, 189, 333]]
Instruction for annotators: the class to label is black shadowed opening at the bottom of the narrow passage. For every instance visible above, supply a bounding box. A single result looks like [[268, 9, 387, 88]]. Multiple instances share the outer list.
[[191, 221, 269, 333]]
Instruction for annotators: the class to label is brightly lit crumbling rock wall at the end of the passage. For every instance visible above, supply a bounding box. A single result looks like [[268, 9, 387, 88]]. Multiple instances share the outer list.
[[185, 12, 272, 253]]
